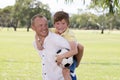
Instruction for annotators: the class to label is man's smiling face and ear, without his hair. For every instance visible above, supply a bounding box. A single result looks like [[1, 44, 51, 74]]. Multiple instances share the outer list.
[[33, 17, 48, 37]]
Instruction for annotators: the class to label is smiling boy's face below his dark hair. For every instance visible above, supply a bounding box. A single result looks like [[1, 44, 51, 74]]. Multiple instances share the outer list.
[[54, 19, 68, 34]]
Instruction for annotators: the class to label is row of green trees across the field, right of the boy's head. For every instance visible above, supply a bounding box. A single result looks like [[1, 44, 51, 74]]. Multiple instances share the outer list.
[[70, 13, 120, 30]]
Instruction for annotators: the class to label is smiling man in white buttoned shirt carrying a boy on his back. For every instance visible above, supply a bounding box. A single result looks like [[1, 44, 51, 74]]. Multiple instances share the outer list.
[[31, 14, 73, 80]]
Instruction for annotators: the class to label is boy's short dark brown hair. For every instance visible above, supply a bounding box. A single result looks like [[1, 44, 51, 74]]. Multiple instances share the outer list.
[[54, 11, 69, 25]]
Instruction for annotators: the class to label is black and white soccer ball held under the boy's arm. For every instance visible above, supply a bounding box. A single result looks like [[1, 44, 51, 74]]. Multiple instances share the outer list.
[[57, 48, 73, 68]]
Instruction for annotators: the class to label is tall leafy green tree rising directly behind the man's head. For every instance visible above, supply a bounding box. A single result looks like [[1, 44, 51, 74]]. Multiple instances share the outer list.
[[13, 0, 51, 31]]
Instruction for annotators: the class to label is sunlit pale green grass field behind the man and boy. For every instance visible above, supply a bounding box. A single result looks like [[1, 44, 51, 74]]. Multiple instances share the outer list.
[[0, 29, 120, 80]]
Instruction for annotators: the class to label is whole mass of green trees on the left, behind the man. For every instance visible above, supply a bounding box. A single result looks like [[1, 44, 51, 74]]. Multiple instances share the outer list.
[[0, 0, 51, 31]]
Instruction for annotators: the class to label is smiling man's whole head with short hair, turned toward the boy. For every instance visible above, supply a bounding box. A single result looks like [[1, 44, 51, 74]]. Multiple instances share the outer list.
[[31, 14, 48, 37]]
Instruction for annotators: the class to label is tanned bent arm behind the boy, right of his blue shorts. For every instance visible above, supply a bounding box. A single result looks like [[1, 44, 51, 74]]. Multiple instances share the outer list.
[[75, 43, 84, 67]]
